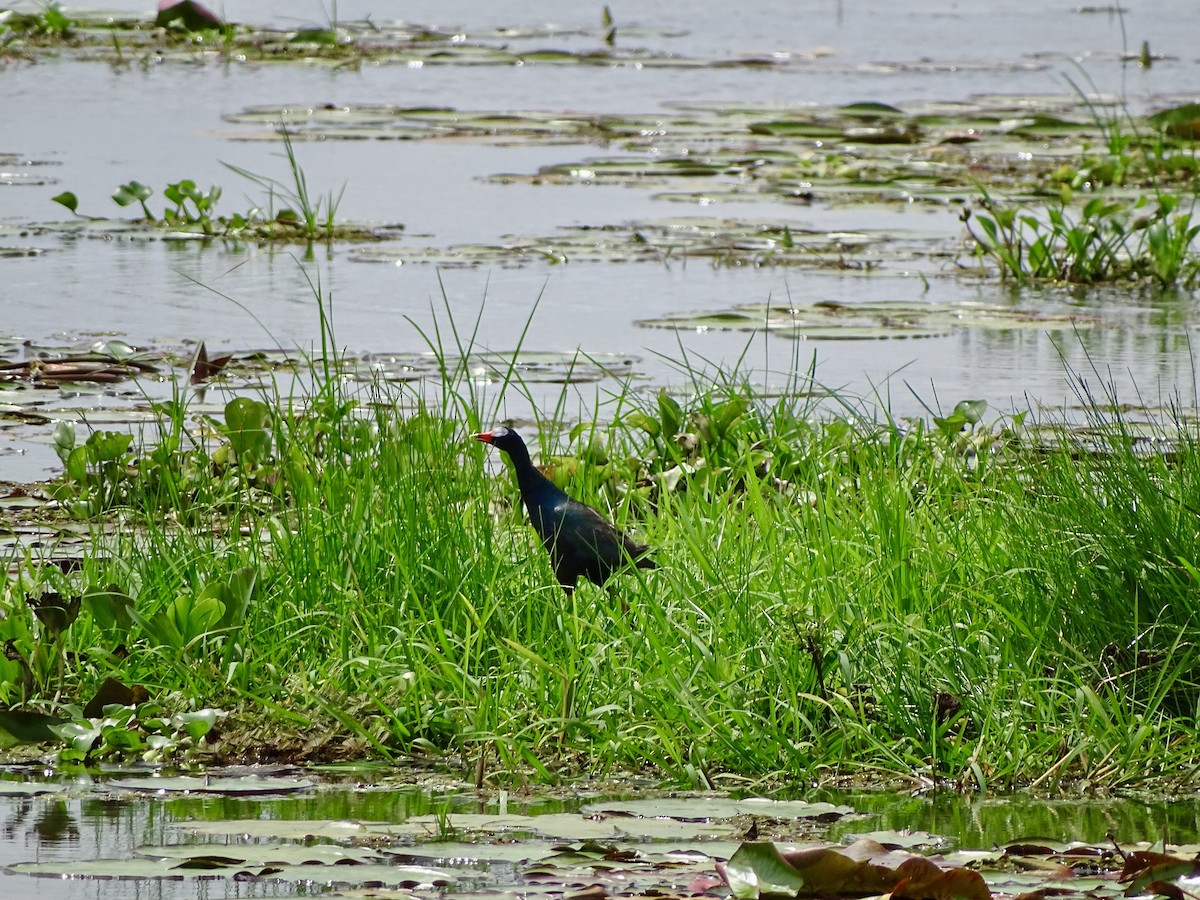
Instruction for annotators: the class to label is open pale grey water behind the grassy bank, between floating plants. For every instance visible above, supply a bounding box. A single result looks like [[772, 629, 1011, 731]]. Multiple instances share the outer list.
[[0, 0, 1196, 478]]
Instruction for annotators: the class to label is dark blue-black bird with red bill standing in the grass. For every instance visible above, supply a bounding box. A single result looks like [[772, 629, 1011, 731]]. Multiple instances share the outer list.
[[475, 426, 658, 596]]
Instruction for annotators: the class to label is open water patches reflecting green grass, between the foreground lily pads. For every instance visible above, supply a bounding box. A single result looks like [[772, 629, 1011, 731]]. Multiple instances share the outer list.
[[0, 775, 1200, 900]]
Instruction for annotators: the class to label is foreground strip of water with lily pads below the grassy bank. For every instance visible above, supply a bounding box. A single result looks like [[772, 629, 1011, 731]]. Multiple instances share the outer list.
[[0, 766, 1196, 900]]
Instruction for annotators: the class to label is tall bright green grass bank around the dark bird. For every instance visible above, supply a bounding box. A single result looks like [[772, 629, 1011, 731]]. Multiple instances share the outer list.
[[7, 300, 1200, 790]]
